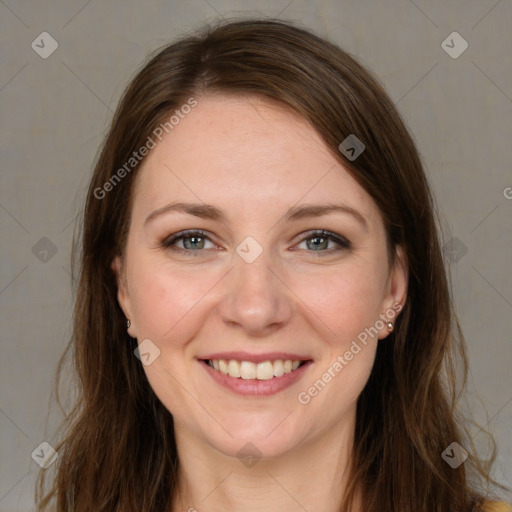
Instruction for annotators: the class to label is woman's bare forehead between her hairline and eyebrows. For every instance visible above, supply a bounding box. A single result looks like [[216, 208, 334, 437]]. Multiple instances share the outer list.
[[134, 95, 378, 226]]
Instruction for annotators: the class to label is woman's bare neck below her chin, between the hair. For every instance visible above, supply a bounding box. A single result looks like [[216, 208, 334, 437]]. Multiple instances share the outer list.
[[171, 411, 361, 512]]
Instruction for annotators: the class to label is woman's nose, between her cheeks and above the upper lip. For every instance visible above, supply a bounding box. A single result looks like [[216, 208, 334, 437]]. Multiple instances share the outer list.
[[219, 251, 293, 337]]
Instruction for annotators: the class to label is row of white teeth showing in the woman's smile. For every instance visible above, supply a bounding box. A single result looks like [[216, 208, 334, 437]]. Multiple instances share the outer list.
[[208, 359, 302, 380]]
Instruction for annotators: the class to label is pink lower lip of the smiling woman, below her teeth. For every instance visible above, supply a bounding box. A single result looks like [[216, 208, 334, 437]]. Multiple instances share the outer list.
[[199, 361, 313, 396]]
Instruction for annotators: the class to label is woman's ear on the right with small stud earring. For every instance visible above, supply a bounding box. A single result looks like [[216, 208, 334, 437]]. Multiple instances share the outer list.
[[379, 245, 409, 339]]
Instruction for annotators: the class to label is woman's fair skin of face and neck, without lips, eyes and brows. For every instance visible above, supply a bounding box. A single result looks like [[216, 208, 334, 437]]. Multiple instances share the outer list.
[[113, 95, 407, 512]]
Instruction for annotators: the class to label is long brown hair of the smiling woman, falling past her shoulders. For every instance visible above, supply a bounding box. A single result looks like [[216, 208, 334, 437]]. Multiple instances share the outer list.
[[36, 20, 508, 512]]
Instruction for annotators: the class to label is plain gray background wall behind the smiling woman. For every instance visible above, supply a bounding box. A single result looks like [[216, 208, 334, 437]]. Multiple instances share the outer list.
[[0, 0, 512, 512]]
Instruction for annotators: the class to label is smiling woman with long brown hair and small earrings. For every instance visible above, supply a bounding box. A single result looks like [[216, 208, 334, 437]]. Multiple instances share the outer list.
[[35, 20, 509, 512]]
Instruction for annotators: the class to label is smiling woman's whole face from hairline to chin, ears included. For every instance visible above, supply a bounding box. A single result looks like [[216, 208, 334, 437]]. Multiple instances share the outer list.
[[114, 95, 406, 457]]
